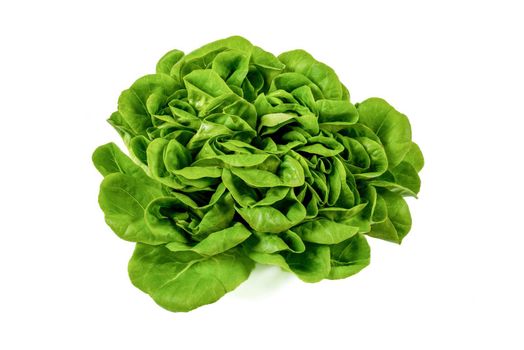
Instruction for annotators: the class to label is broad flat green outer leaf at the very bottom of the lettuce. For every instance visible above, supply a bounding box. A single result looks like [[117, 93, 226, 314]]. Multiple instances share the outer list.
[[128, 244, 254, 312]]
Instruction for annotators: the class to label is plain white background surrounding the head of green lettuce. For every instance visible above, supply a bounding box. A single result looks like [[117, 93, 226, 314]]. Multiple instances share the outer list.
[[0, 0, 524, 349]]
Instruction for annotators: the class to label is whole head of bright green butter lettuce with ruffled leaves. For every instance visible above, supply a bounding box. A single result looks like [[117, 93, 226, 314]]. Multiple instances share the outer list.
[[93, 37, 424, 311]]
